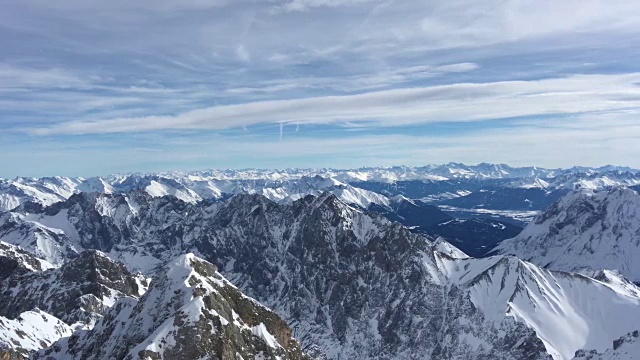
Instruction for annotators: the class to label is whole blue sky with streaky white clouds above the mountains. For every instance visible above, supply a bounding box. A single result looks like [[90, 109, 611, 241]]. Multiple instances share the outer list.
[[0, 0, 640, 178]]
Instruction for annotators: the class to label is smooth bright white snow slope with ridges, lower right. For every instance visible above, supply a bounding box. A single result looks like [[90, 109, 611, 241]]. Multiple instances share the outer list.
[[439, 256, 640, 359]]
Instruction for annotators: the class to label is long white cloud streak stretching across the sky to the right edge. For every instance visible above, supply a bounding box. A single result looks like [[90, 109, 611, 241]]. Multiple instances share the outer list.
[[26, 73, 640, 135]]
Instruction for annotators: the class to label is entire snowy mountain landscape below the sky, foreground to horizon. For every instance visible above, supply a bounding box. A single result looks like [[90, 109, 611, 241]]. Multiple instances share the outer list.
[[0, 164, 640, 359]]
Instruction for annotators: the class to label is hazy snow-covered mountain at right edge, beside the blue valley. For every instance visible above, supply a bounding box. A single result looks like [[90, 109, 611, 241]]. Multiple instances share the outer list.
[[495, 188, 640, 282]]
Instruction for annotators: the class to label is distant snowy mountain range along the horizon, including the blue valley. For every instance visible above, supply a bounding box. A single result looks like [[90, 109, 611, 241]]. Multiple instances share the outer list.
[[0, 163, 640, 226]]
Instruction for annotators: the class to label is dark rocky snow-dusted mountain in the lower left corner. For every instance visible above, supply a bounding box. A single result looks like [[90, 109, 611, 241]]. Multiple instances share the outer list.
[[0, 242, 146, 359]]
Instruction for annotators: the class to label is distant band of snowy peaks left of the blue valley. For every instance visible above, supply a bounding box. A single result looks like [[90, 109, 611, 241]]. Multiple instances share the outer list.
[[0, 174, 389, 211]]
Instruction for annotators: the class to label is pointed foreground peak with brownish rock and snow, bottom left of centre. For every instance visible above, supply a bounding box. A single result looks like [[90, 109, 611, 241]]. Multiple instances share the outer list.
[[35, 254, 306, 360]]
